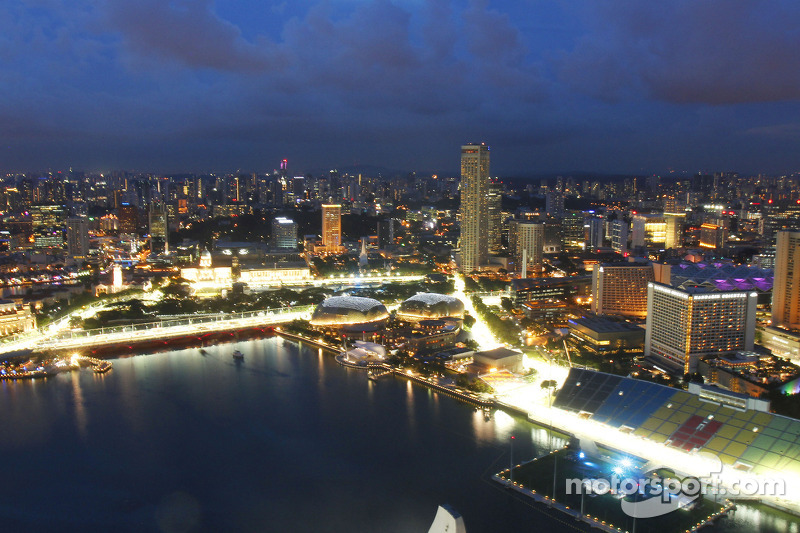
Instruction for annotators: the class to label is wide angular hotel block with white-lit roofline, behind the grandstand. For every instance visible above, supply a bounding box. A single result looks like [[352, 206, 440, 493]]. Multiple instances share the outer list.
[[644, 283, 758, 374]]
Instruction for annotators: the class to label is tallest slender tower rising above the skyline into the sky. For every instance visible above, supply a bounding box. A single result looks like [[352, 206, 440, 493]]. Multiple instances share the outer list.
[[460, 143, 489, 273]]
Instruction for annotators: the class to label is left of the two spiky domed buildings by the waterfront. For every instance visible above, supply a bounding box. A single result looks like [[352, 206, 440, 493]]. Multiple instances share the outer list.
[[310, 296, 389, 331]]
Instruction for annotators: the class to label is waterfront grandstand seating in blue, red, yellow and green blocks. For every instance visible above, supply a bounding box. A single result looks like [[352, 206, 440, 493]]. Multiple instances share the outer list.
[[553, 368, 800, 475]]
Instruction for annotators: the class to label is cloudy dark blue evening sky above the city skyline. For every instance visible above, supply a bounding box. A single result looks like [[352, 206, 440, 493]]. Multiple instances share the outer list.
[[0, 0, 800, 176]]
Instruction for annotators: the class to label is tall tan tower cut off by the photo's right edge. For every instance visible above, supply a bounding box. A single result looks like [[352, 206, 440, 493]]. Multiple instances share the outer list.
[[772, 231, 800, 329]]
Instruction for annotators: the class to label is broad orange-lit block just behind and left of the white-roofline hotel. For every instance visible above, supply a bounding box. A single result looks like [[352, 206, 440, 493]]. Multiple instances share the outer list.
[[592, 262, 654, 318]]
